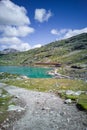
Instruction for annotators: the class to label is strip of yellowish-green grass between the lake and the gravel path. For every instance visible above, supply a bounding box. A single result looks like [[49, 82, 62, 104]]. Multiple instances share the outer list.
[[1, 78, 87, 92]]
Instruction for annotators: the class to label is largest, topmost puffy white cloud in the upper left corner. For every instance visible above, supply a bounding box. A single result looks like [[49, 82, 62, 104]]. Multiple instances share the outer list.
[[0, 0, 30, 26]]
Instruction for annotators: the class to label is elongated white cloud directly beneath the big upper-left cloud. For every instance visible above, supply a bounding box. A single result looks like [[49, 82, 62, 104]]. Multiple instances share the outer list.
[[0, 26, 34, 37]]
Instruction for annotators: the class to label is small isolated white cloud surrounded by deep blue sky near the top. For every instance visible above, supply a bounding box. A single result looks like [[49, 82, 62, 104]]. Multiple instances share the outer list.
[[34, 9, 52, 23]]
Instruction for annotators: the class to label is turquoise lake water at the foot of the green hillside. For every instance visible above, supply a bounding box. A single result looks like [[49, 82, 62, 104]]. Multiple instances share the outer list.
[[0, 66, 52, 78]]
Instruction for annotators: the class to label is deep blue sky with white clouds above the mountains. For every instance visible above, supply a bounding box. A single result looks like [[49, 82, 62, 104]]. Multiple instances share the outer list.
[[0, 0, 87, 51]]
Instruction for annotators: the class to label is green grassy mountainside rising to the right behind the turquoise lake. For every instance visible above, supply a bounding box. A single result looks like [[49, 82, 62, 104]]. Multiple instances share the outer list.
[[0, 33, 87, 65]]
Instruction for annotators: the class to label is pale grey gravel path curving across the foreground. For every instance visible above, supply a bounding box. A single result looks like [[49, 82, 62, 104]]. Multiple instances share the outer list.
[[0, 83, 87, 130]]
